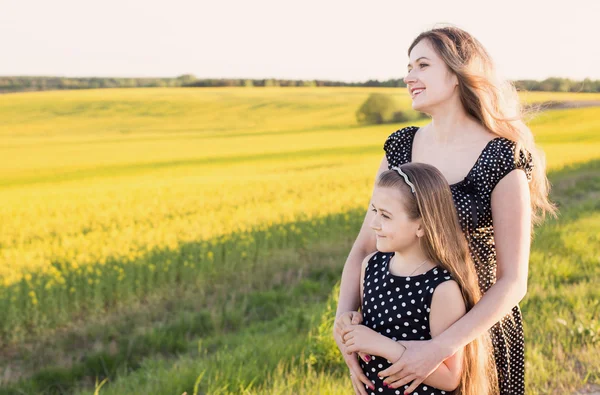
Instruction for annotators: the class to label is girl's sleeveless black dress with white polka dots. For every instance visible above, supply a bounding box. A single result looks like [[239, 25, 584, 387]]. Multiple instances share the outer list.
[[359, 251, 453, 395]]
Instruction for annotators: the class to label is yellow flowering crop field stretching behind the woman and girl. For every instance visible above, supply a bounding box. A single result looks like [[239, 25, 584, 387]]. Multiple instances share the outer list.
[[0, 88, 600, 344]]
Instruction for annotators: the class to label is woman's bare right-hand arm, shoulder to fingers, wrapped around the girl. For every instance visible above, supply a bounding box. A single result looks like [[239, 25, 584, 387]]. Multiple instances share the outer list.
[[381, 170, 531, 393]]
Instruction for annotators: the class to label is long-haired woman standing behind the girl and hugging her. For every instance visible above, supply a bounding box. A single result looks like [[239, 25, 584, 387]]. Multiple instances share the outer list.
[[334, 27, 555, 395]]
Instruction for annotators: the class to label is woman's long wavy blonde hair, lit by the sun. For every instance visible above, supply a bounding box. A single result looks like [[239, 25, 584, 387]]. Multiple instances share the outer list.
[[408, 26, 556, 225]]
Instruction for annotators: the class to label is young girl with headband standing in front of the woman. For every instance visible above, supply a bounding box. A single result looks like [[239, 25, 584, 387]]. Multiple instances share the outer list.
[[342, 163, 497, 395]]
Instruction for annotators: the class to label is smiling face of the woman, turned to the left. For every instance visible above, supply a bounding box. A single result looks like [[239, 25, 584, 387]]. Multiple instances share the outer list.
[[404, 39, 458, 115]]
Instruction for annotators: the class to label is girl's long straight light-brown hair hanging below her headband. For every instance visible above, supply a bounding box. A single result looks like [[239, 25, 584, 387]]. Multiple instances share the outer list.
[[376, 163, 498, 395]]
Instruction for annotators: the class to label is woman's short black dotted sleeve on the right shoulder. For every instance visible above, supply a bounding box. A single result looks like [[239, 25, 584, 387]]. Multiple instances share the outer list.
[[486, 138, 534, 193]]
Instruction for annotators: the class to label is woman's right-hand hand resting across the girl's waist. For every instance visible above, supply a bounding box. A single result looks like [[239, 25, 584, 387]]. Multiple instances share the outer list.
[[379, 340, 444, 394]]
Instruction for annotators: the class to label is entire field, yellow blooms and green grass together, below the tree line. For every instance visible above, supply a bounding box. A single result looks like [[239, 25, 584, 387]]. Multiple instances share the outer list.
[[0, 88, 600, 394]]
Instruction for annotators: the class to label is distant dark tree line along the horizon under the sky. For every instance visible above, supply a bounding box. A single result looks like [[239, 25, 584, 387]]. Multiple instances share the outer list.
[[0, 74, 600, 93]]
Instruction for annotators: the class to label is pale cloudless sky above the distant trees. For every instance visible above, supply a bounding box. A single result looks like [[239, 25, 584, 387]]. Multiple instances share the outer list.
[[0, 0, 600, 81]]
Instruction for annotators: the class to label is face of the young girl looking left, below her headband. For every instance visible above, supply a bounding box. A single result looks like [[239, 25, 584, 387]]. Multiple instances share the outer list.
[[370, 187, 425, 252]]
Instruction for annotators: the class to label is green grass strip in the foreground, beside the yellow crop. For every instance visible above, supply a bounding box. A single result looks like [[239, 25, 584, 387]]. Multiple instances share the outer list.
[[0, 161, 600, 394]]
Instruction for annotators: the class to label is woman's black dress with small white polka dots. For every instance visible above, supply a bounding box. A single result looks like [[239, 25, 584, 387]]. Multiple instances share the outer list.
[[384, 126, 533, 395]]
